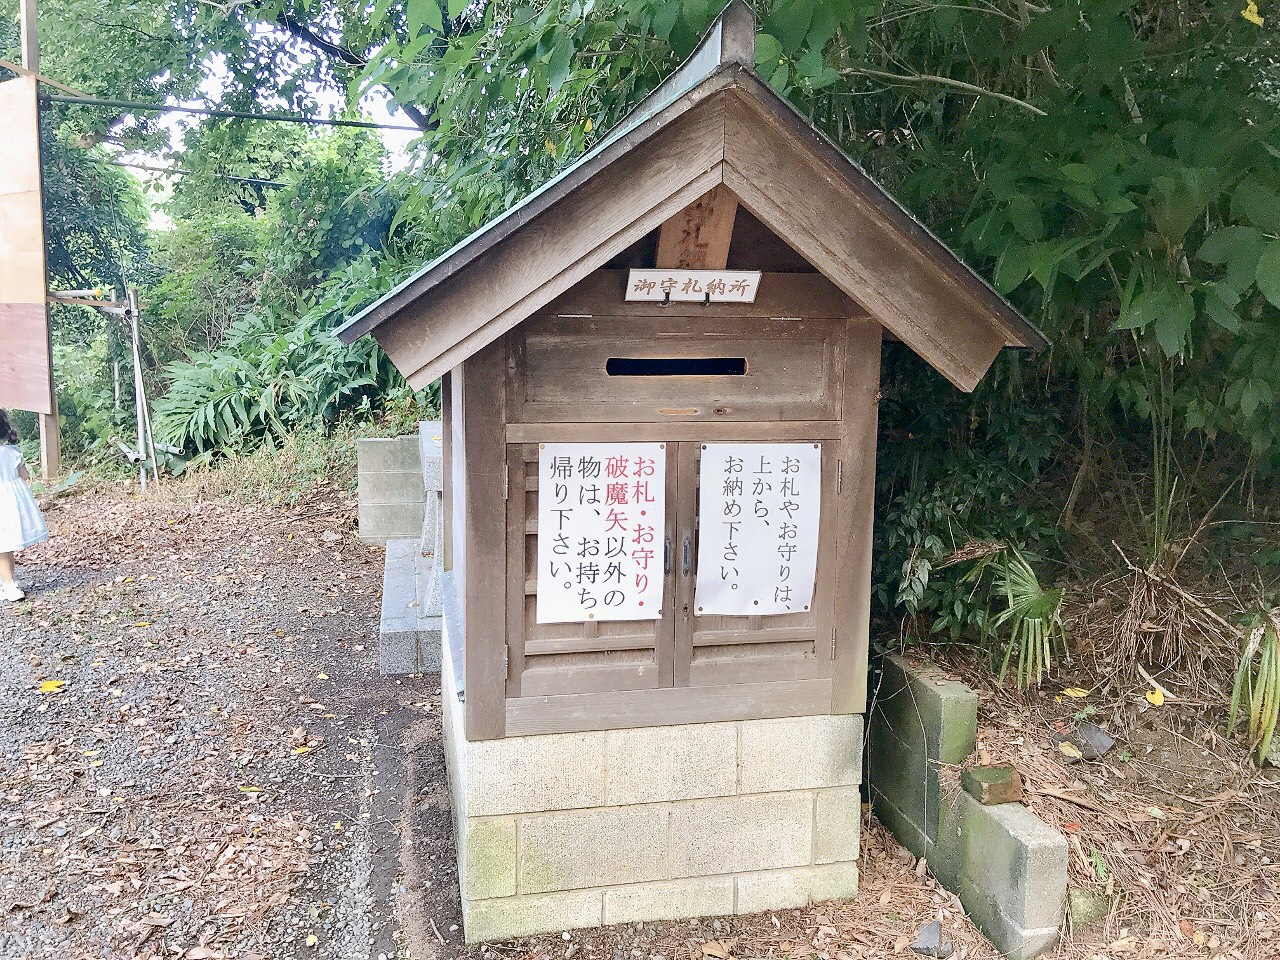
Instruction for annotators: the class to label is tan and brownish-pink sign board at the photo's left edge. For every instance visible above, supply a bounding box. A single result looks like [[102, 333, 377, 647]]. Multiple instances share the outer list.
[[0, 77, 54, 413]]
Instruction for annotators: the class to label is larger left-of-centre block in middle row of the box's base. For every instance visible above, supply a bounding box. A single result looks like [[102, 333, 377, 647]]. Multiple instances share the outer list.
[[518, 804, 668, 895]]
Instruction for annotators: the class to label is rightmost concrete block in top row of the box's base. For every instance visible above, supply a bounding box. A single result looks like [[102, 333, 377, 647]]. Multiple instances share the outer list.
[[739, 714, 863, 794]]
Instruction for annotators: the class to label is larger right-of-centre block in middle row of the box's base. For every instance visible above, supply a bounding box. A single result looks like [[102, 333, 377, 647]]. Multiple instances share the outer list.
[[671, 792, 813, 877]]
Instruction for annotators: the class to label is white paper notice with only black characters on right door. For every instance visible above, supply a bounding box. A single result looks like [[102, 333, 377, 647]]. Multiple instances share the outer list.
[[694, 443, 822, 617]]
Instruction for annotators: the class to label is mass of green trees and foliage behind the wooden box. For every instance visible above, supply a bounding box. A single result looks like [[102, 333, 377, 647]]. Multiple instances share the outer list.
[[22, 0, 1280, 701]]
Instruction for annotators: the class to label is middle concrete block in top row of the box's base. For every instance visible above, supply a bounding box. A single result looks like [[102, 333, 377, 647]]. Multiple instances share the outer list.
[[605, 723, 737, 804]]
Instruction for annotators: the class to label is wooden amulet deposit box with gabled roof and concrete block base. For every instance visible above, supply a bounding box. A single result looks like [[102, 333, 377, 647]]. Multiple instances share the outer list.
[[339, 3, 1042, 941]]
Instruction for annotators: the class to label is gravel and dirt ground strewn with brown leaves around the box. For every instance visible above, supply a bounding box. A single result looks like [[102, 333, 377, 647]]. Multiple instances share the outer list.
[[0, 484, 1280, 960]]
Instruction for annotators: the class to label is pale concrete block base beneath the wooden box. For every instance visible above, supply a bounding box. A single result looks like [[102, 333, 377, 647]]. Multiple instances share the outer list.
[[440, 652, 863, 943]]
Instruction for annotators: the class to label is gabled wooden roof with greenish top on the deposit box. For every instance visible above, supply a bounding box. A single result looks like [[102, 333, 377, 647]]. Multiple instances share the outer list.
[[338, 0, 1044, 390]]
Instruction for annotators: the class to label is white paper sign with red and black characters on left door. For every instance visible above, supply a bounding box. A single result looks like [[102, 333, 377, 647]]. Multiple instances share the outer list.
[[538, 443, 667, 623]]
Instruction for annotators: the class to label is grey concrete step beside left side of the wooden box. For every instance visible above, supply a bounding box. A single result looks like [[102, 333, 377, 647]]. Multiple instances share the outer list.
[[378, 538, 442, 676]]
